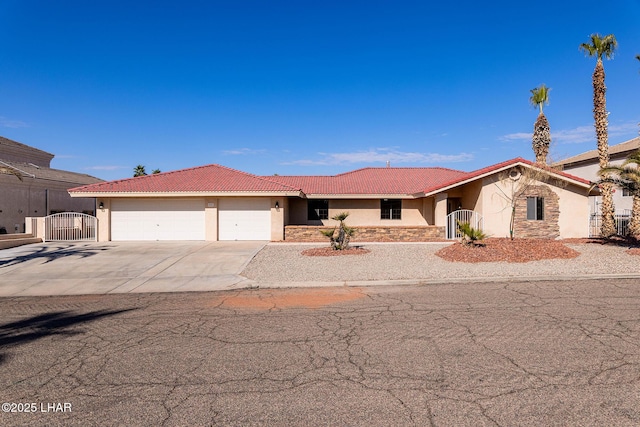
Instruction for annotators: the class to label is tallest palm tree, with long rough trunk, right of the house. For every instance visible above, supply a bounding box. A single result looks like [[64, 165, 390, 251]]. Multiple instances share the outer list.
[[580, 34, 618, 237]]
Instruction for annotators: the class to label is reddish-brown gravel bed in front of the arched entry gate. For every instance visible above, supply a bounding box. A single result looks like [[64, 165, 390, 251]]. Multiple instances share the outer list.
[[436, 238, 580, 263]]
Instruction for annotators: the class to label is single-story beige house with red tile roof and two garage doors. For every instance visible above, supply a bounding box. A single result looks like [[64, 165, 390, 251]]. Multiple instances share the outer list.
[[69, 158, 591, 241]]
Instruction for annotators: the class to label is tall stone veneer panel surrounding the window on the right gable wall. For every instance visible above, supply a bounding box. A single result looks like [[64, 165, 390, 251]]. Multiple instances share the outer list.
[[513, 185, 560, 239]]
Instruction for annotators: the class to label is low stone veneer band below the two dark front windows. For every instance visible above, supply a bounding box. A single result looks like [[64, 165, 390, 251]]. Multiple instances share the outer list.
[[284, 225, 445, 242]]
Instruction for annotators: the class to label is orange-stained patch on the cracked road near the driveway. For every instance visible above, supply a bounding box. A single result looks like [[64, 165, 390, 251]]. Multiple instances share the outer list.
[[208, 287, 366, 310]]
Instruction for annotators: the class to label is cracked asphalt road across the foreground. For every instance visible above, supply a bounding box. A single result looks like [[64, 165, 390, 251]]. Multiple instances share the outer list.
[[0, 280, 640, 426]]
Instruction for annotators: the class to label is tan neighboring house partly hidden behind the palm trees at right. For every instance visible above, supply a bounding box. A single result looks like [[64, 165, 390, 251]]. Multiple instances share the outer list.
[[553, 137, 640, 215]]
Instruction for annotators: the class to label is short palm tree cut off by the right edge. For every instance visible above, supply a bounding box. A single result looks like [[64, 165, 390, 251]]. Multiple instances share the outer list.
[[598, 151, 640, 239]]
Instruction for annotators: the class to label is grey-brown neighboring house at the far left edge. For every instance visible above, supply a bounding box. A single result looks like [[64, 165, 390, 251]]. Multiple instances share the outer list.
[[0, 137, 102, 233]]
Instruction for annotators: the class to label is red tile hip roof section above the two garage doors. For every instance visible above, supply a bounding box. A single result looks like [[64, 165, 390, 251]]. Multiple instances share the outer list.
[[69, 165, 299, 193]]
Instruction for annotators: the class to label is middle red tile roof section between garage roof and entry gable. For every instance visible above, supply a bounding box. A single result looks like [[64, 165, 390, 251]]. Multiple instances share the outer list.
[[269, 167, 466, 195]]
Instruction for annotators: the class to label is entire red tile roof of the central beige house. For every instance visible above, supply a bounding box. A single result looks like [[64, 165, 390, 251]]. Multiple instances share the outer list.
[[69, 157, 590, 196]]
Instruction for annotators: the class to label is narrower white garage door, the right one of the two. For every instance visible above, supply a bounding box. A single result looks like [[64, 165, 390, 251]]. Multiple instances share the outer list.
[[218, 197, 271, 240]]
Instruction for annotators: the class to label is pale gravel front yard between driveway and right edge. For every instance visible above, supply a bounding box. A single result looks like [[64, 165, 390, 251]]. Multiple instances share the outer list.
[[242, 243, 640, 282]]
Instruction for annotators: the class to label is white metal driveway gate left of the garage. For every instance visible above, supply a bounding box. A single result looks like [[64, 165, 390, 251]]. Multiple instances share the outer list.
[[44, 212, 98, 242]]
